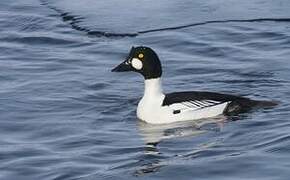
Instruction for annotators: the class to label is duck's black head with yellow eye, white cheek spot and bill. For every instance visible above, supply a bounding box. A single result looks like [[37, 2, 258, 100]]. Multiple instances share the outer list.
[[112, 46, 162, 79]]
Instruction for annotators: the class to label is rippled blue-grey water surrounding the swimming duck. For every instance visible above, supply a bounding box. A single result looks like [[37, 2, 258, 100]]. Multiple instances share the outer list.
[[0, 0, 290, 180]]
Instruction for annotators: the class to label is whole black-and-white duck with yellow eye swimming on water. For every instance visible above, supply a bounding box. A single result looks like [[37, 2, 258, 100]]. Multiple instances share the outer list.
[[111, 46, 276, 124]]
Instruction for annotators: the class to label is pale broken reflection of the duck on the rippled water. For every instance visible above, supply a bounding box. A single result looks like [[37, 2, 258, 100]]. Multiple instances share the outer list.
[[134, 116, 226, 176]]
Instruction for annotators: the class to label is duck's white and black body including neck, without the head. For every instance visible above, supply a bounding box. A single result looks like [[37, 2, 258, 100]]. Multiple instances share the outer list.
[[137, 78, 257, 124]]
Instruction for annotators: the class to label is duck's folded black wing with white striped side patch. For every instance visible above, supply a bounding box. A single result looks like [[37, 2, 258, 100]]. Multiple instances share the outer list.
[[162, 91, 255, 114]]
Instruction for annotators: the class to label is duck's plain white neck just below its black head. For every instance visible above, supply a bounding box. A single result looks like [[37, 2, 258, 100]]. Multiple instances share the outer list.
[[144, 77, 163, 98]]
